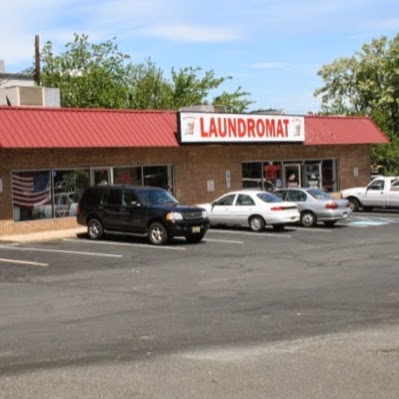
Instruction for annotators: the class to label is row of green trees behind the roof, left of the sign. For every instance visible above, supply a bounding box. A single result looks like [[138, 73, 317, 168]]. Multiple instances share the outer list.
[[41, 33, 252, 112]]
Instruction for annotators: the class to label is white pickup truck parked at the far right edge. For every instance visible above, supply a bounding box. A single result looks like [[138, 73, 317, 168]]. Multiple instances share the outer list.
[[341, 176, 399, 211]]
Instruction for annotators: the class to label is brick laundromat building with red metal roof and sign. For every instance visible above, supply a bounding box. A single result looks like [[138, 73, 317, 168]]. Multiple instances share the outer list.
[[0, 107, 388, 238]]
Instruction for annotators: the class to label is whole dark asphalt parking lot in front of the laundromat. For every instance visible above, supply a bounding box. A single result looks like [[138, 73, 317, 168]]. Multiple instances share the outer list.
[[0, 212, 399, 399]]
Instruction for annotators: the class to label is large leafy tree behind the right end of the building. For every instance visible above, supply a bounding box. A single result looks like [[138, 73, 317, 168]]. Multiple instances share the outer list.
[[314, 34, 399, 174]]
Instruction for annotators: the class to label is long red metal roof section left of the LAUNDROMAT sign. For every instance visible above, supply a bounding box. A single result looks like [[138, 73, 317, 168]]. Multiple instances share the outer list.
[[0, 107, 178, 148]]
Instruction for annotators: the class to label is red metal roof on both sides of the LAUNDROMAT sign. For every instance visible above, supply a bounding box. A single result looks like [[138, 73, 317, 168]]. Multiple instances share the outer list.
[[0, 107, 389, 148]]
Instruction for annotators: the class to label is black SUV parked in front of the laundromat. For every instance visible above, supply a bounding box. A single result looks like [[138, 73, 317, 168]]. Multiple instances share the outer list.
[[76, 184, 209, 245]]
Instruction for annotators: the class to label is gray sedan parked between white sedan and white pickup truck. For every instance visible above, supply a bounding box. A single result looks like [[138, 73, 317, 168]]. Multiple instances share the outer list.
[[273, 188, 352, 227]]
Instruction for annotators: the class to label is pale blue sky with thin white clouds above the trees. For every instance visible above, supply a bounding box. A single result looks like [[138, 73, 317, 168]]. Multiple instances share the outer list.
[[0, 0, 399, 114]]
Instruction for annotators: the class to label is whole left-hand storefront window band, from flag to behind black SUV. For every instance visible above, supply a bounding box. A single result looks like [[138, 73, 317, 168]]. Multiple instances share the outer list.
[[12, 165, 173, 221]]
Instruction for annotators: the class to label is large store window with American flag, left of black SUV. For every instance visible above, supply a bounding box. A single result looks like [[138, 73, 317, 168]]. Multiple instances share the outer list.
[[12, 170, 89, 221]]
